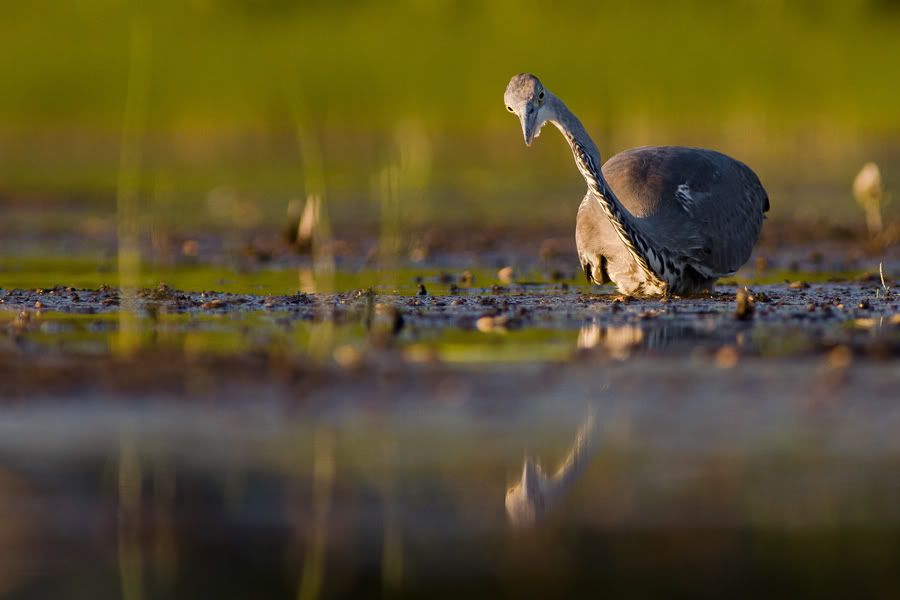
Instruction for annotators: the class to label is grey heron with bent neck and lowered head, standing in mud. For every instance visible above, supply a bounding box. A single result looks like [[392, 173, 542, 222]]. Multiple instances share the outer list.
[[504, 73, 769, 296]]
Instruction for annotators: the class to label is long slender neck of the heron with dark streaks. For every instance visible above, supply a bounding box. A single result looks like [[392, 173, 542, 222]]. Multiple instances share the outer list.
[[548, 94, 664, 285]]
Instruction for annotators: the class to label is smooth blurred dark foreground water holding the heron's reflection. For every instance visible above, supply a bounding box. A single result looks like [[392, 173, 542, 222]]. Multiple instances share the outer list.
[[0, 357, 900, 598]]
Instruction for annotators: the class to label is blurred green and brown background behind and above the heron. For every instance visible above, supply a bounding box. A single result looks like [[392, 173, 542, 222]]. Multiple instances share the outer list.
[[0, 0, 900, 227]]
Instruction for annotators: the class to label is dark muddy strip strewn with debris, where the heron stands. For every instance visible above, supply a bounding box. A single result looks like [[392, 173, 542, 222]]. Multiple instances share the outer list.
[[0, 282, 900, 397]]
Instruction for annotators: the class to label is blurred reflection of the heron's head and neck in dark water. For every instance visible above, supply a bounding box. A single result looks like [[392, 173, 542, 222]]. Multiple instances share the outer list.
[[506, 413, 597, 528]]
